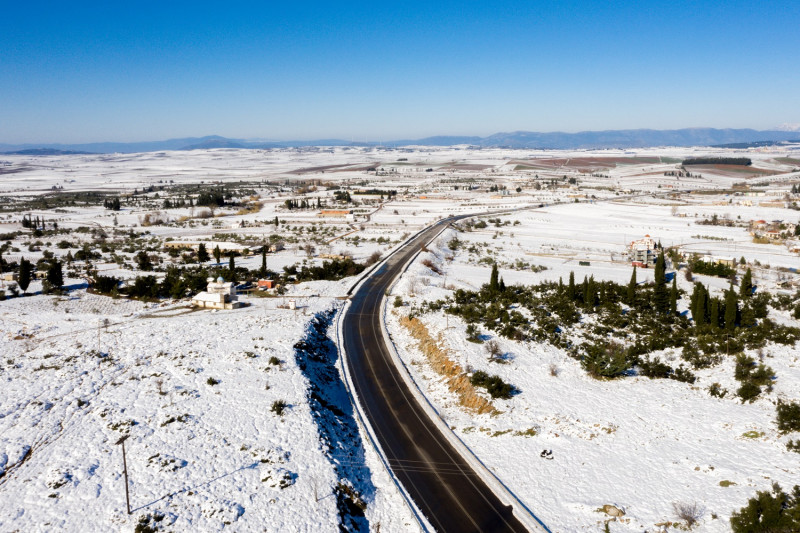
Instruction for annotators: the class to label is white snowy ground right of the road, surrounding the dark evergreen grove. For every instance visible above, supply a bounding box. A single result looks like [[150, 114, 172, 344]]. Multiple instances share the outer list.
[[387, 219, 800, 532]]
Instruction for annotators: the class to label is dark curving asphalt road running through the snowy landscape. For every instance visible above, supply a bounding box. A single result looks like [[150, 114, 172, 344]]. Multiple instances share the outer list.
[[342, 217, 527, 532]]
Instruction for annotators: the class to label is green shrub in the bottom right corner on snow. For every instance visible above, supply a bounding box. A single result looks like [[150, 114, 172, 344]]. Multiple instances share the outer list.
[[731, 483, 800, 533]]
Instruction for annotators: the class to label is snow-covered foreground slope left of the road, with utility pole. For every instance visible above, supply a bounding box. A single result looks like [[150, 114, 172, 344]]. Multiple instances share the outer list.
[[0, 291, 412, 531]]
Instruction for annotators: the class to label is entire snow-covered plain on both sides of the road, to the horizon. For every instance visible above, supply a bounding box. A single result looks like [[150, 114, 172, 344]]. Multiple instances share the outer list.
[[0, 147, 800, 531]]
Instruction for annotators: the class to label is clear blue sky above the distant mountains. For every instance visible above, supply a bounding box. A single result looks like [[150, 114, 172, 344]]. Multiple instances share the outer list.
[[0, 0, 800, 143]]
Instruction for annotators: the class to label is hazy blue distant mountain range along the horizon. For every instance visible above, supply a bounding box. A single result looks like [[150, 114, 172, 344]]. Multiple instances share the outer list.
[[0, 125, 800, 155]]
